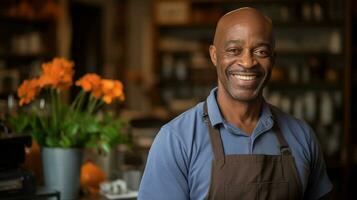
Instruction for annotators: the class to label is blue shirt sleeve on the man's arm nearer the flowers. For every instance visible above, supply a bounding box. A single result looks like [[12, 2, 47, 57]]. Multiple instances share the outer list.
[[138, 126, 189, 200]]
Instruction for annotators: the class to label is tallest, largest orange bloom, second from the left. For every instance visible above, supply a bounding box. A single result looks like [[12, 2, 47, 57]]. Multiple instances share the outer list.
[[39, 58, 74, 90]]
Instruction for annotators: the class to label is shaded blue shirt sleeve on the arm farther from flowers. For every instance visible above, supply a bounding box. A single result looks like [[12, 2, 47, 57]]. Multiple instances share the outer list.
[[305, 128, 332, 200]]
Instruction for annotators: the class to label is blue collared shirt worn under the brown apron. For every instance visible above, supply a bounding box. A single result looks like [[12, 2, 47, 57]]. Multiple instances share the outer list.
[[138, 88, 332, 200]]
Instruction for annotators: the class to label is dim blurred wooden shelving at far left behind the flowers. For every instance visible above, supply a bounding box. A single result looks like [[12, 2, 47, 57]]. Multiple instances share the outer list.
[[0, 1, 57, 99]]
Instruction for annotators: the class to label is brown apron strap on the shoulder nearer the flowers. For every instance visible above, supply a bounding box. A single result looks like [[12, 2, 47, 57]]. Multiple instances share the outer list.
[[203, 101, 225, 167]]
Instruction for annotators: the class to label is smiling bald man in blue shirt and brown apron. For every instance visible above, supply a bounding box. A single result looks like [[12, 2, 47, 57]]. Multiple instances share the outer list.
[[139, 8, 332, 200]]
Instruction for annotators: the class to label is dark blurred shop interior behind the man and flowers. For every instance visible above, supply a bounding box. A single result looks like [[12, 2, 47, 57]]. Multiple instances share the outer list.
[[0, 0, 357, 199]]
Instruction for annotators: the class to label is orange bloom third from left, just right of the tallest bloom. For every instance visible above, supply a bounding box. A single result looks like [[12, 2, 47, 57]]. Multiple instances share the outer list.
[[76, 73, 102, 99]]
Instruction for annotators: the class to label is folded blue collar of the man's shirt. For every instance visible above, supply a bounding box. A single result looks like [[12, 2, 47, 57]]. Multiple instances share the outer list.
[[207, 87, 273, 133]]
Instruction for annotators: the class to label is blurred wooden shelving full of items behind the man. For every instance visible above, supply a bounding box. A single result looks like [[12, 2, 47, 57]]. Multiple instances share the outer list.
[[153, 0, 350, 197]]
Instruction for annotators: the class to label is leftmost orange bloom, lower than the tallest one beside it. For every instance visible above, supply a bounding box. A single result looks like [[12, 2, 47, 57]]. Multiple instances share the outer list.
[[17, 79, 41, 106]]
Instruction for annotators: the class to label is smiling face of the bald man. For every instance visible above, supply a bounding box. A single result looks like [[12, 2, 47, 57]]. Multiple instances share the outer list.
[[210, 23, 274, 102]]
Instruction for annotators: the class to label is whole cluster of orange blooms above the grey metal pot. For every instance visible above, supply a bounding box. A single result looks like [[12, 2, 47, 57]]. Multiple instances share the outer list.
[[18, 58, 125, 105]]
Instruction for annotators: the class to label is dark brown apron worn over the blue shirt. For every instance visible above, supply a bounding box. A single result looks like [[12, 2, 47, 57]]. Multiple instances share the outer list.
[[204, 103, 302, 200]]
